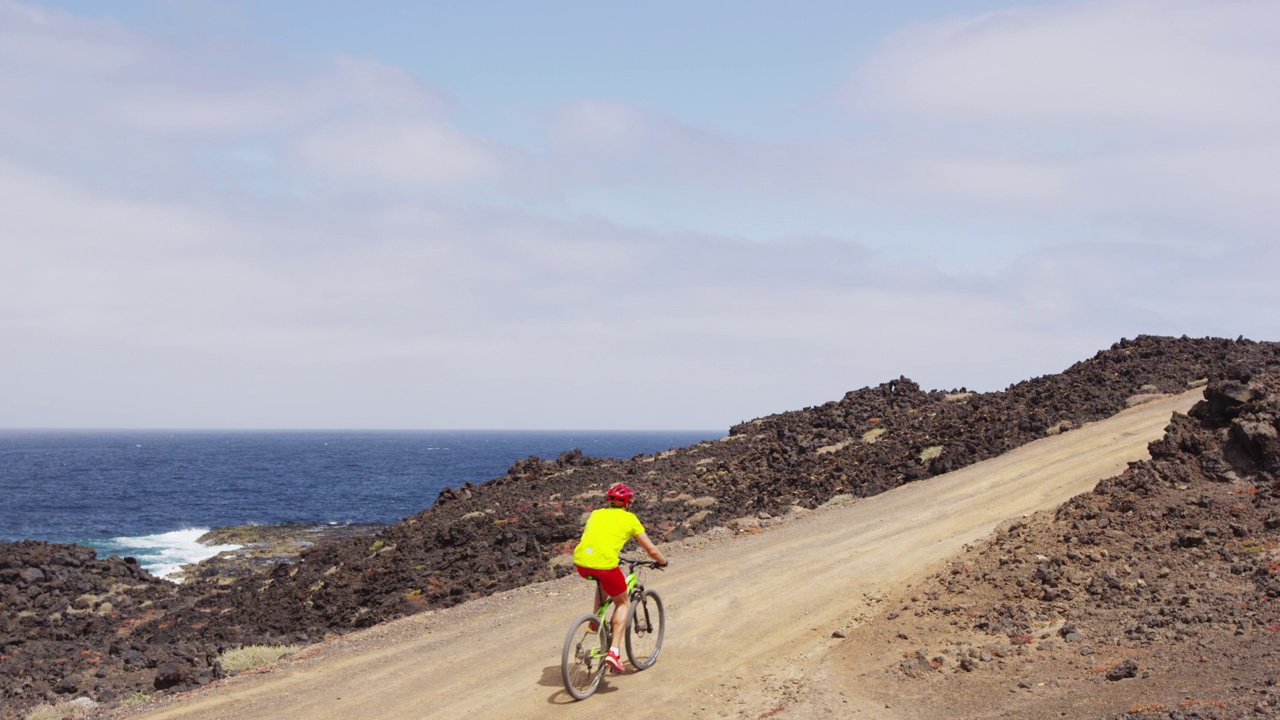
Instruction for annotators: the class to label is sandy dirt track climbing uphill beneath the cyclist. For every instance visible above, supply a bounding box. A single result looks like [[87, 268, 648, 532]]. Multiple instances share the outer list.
[[132, 391, 1201, 720]]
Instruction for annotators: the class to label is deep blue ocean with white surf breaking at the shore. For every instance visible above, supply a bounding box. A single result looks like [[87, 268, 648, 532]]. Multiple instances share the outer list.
[[0, 430, 724, 577]]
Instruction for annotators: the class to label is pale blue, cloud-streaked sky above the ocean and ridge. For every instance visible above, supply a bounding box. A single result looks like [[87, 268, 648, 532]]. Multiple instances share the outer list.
[[0, 0, 1280, 432]]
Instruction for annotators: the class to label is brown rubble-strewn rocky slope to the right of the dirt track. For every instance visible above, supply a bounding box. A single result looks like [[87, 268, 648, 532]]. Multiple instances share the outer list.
[[851, 354, 1280, 720]]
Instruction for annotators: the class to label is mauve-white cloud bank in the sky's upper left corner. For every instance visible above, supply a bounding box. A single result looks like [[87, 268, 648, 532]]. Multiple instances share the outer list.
[[0, 0, 494, 196]]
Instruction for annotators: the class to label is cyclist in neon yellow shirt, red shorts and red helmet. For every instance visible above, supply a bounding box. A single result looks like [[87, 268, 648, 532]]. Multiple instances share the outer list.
[[573, 483, 667, 673]]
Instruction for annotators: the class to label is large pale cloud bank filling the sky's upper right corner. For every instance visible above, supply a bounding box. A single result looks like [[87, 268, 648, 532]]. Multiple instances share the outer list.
[[836, 0, 1280, 242]]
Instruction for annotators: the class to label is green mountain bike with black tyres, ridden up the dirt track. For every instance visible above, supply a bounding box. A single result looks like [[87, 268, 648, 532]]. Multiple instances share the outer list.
[[561, 557, 667, 700]]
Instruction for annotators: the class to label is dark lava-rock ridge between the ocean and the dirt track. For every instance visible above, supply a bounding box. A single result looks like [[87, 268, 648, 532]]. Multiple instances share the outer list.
[[0, 336, 1280, 719]]
